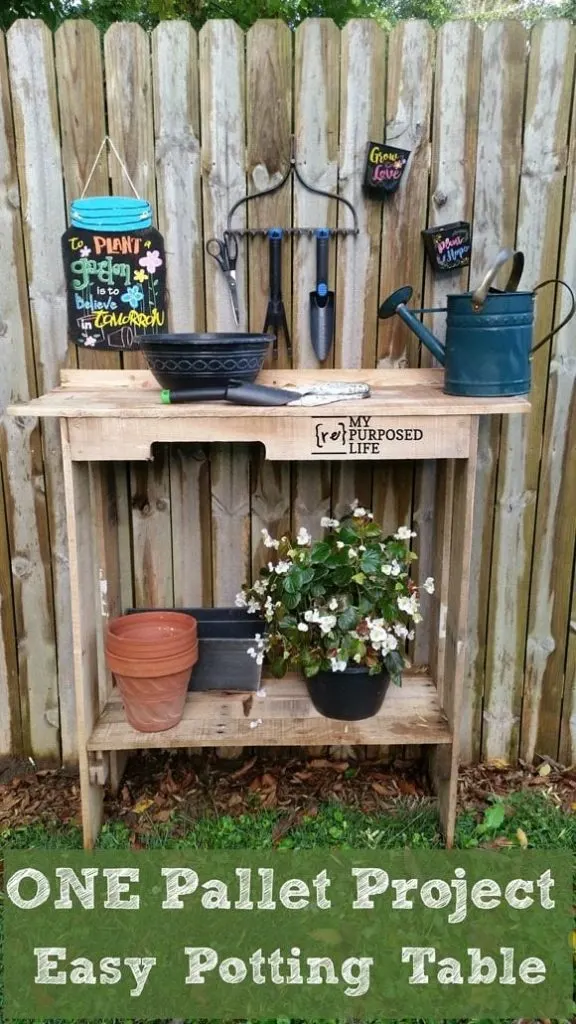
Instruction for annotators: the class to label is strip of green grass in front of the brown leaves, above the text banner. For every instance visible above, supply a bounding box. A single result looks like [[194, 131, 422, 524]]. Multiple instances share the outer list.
[[0, 792, 576, 1024]]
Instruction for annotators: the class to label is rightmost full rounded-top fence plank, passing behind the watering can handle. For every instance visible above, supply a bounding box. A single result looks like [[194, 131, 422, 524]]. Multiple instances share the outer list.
[[483, 20, 573, 758]]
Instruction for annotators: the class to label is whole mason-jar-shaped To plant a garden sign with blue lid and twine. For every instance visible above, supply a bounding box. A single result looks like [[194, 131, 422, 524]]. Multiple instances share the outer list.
[[63, 138, 167, 350]]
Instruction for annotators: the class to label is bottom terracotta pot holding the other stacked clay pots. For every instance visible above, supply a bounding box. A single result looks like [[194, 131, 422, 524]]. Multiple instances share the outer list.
[[106, 641, 198, 732]]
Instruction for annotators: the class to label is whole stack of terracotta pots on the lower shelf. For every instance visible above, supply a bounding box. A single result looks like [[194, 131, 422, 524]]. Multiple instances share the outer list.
[[106, 611, 198, 732]]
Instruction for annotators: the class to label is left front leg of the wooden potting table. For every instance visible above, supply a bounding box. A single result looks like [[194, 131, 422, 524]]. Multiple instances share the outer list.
[[60, 420, 104, 849]]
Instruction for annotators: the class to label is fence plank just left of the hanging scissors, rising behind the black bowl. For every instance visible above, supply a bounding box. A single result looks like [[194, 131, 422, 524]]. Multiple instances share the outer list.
[[152, 22, 208, 606]]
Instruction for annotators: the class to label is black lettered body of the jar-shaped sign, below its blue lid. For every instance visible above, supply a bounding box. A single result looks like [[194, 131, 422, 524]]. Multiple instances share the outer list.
[[63, 227, 166, 349]]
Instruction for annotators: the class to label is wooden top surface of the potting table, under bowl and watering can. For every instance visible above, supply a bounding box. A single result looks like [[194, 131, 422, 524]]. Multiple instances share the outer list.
[[8, 370, 530, 420]]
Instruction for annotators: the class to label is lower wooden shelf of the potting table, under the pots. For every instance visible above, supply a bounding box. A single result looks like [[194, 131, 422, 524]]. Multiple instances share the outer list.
[[87, 674, 452, 751]]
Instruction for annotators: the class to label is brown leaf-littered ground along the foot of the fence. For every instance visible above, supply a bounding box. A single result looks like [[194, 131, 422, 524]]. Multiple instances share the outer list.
[[0, 751, 576, 833]]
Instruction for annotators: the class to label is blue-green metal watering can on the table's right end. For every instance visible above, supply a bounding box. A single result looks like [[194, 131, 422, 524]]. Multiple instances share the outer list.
[[378, 249, 576, 397]]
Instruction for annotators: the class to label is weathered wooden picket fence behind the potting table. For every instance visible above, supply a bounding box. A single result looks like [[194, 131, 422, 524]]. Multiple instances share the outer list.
[[0, 20, 576, 763]]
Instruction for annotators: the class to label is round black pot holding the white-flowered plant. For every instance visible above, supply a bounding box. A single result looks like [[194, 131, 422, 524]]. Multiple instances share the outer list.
[[306, 665, 390, 722]]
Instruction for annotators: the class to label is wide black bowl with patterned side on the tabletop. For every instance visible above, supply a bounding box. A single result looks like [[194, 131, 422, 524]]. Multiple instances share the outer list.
[[138, 333, 274, 391]]
